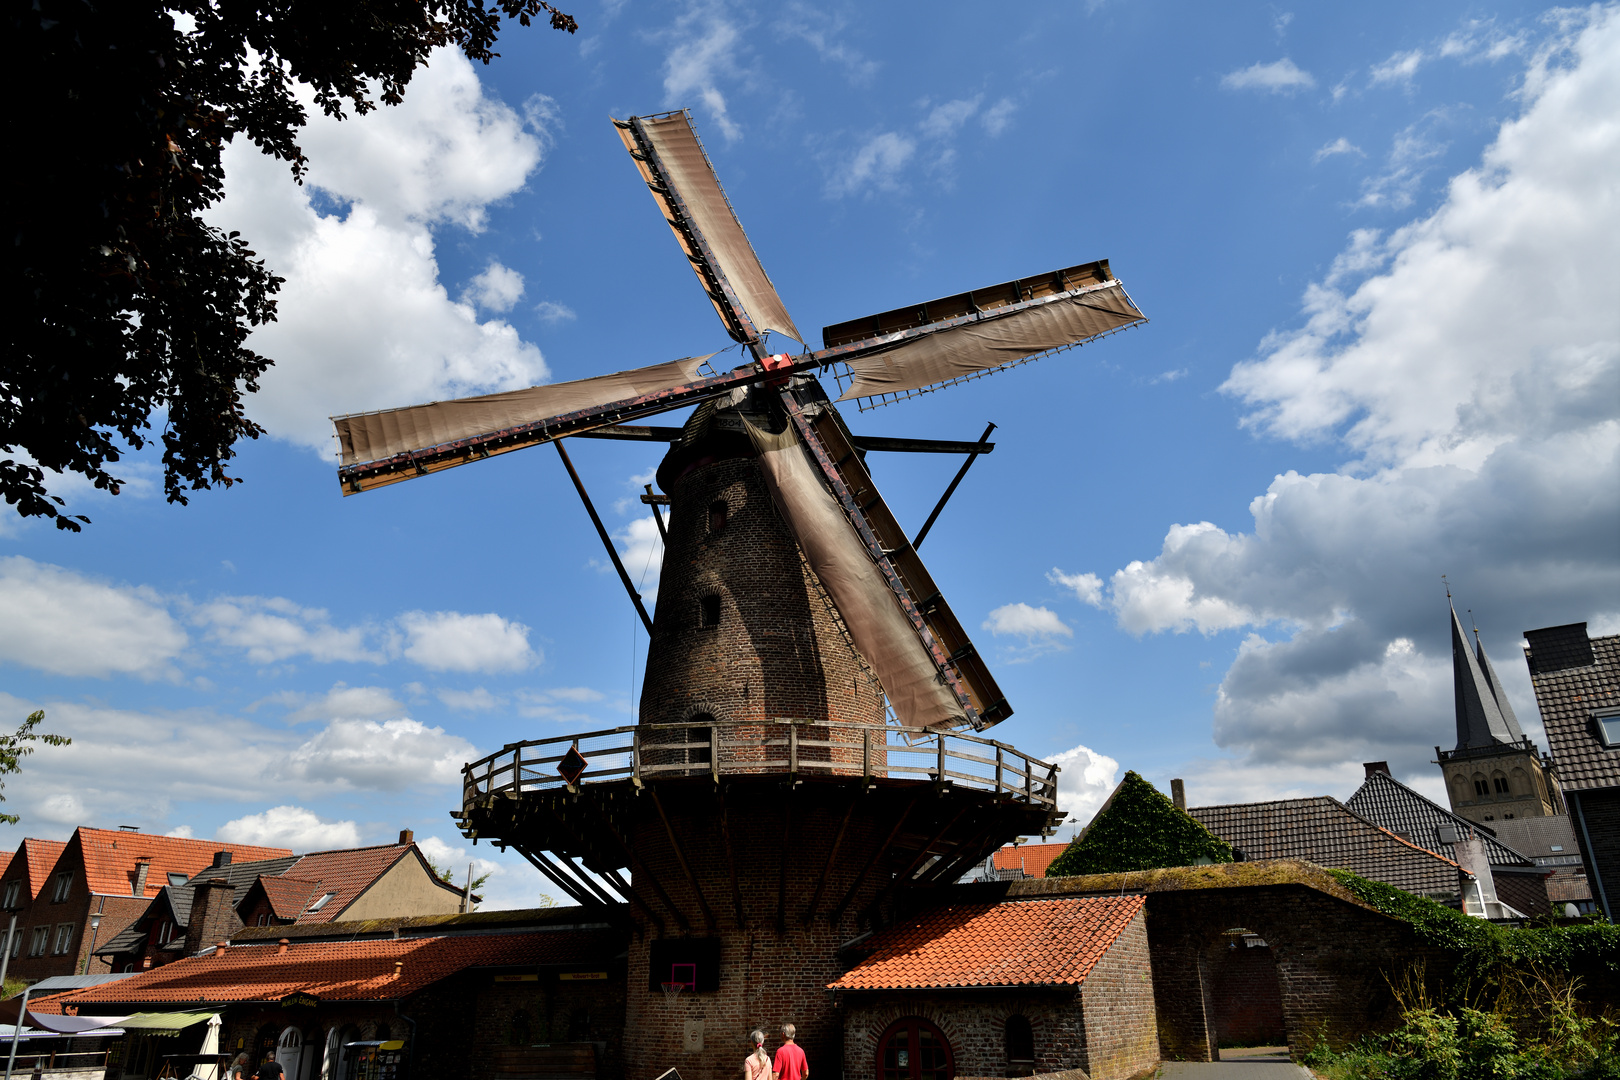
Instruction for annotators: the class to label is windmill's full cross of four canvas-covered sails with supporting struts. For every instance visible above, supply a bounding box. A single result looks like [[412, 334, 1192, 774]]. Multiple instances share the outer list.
[[334, 110, 1145, 730]]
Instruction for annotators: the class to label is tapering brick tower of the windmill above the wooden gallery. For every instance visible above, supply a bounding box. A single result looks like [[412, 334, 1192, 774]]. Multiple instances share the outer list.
[[640, 458, 883, 724]]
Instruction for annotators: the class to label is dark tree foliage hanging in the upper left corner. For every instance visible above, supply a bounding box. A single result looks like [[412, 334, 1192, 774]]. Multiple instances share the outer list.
[[0, 0, 577, 531]]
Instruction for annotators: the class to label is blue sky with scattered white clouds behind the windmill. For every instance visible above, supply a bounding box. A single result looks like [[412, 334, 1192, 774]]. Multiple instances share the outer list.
[[0, 0, 1620, 904]]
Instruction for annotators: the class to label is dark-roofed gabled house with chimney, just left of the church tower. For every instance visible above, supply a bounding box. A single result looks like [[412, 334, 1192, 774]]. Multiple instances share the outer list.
[[1345, 761, 1568, 915]]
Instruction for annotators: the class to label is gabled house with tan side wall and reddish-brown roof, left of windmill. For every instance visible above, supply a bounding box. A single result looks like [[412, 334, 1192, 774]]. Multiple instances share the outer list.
[[96, 829, 462, 972]]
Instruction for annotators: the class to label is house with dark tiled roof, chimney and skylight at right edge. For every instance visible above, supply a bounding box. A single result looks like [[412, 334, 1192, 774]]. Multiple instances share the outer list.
[[1524, 622, 1620, 920]]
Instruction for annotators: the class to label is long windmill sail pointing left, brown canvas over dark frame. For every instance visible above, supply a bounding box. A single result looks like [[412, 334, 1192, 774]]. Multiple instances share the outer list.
[[332, 353, 726, 492]]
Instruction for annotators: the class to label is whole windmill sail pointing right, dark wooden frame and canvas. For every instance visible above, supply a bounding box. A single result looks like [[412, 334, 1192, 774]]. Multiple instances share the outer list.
[[818, 261, 1147, 408]]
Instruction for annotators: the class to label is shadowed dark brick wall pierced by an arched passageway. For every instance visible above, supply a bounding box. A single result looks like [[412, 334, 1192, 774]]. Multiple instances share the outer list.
[[1147, 886, 1439, 1061]]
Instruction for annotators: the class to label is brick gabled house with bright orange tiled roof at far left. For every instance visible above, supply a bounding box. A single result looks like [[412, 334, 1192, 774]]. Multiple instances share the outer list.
[[0, 826, 292, 983]]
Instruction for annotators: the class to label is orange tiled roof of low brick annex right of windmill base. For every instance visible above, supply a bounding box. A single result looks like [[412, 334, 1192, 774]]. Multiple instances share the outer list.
[[829, 895, 1147, 989]]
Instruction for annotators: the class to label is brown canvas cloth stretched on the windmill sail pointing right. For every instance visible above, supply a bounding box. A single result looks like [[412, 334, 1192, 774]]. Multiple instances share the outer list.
[[838, 285, 1144, 402]]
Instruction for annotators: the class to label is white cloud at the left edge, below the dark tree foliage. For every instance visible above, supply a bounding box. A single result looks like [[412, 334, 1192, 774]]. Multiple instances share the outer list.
[[0, 555, 186, 678]]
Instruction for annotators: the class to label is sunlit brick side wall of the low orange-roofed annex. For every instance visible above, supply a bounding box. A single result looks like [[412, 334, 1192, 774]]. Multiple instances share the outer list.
[[1081, 910, 1158, 1080]]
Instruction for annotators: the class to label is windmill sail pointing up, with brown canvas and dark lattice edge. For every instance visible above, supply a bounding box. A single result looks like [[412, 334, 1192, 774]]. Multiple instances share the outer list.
[[614, 112, 804, 342]]
